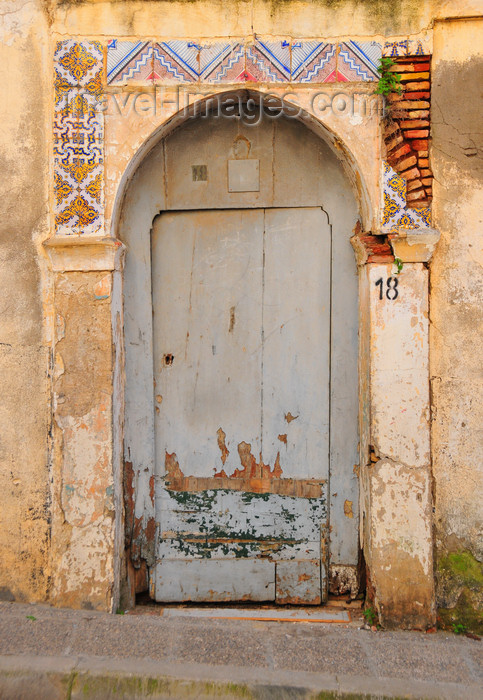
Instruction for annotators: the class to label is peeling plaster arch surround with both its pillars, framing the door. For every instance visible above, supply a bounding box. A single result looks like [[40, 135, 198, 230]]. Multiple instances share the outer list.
[[44, 85, 439, 628]]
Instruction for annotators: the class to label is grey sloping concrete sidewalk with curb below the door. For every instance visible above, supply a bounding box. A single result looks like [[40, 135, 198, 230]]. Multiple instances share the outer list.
[[0, 603, 483, 700]]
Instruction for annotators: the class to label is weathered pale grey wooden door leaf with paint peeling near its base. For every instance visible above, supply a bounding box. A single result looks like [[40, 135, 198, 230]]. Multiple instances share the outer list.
[[152, 207, 331, 604]]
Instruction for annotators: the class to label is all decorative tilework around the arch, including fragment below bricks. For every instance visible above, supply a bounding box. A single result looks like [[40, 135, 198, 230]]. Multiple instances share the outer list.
[[53, 38, 431, 235]]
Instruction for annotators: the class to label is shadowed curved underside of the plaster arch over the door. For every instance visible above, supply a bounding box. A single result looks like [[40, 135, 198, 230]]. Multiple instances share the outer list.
[[110, 88, 374, 238]]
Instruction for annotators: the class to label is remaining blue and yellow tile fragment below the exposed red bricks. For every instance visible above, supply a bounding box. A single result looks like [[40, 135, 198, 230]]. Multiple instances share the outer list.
[[382, 161, 431, 233]]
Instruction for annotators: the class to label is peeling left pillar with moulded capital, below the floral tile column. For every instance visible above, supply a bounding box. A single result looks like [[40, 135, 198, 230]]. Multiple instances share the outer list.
[[45, 235, 123, 611]]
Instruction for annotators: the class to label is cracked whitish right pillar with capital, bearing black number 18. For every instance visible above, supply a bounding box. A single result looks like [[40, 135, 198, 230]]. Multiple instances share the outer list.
[[359, 229, 439, 629]]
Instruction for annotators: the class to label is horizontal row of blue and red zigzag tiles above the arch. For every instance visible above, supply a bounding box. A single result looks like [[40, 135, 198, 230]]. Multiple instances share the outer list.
[[106, 38, 382, 85]]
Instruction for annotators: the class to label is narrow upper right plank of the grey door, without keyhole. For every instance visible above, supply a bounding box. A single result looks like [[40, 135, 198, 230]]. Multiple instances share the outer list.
[[262, 208, 330, 478]]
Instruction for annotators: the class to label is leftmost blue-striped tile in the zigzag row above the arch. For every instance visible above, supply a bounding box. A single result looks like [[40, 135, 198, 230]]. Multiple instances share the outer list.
[[106, 39, 153, 85]]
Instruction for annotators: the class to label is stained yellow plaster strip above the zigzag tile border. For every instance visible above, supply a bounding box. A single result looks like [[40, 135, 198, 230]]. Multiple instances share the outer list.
[[47, 0, 481, 39]]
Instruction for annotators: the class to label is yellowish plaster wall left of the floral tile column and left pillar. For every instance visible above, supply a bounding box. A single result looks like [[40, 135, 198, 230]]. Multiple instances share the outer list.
[[0, 0, 51, 600]]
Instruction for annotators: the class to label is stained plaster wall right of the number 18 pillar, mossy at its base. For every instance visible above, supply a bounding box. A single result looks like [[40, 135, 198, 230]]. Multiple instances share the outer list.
[[431, 20, 483, 630]]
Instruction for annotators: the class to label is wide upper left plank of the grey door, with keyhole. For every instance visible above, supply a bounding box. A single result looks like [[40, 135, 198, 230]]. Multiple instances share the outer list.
[[152, 210, 263, 477]]
